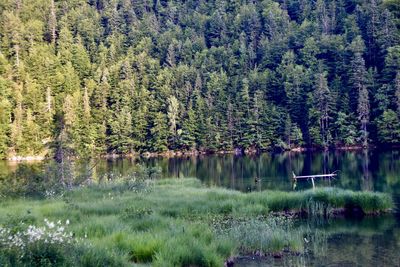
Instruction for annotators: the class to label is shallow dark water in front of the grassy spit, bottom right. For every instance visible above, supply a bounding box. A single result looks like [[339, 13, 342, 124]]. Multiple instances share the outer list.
[[236, 215, 400, 267]]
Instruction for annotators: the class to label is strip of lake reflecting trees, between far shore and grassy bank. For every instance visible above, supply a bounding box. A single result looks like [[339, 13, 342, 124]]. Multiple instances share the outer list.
[[0, 151, 400, 199]]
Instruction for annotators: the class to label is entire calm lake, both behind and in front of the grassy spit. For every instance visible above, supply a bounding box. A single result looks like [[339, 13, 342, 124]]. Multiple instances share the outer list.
[[0, 150, 400, 266]]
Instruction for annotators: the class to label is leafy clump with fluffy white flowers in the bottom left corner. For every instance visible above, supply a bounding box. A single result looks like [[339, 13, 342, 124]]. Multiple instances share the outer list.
[[0, 219, 125, 266]]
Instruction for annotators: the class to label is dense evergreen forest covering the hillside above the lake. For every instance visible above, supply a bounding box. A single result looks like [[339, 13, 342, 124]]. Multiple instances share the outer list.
[[0, 0, 400, 157]]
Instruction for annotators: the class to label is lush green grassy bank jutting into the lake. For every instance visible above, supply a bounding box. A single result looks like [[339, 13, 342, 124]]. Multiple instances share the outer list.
[[0, 179, 393, 266]]
